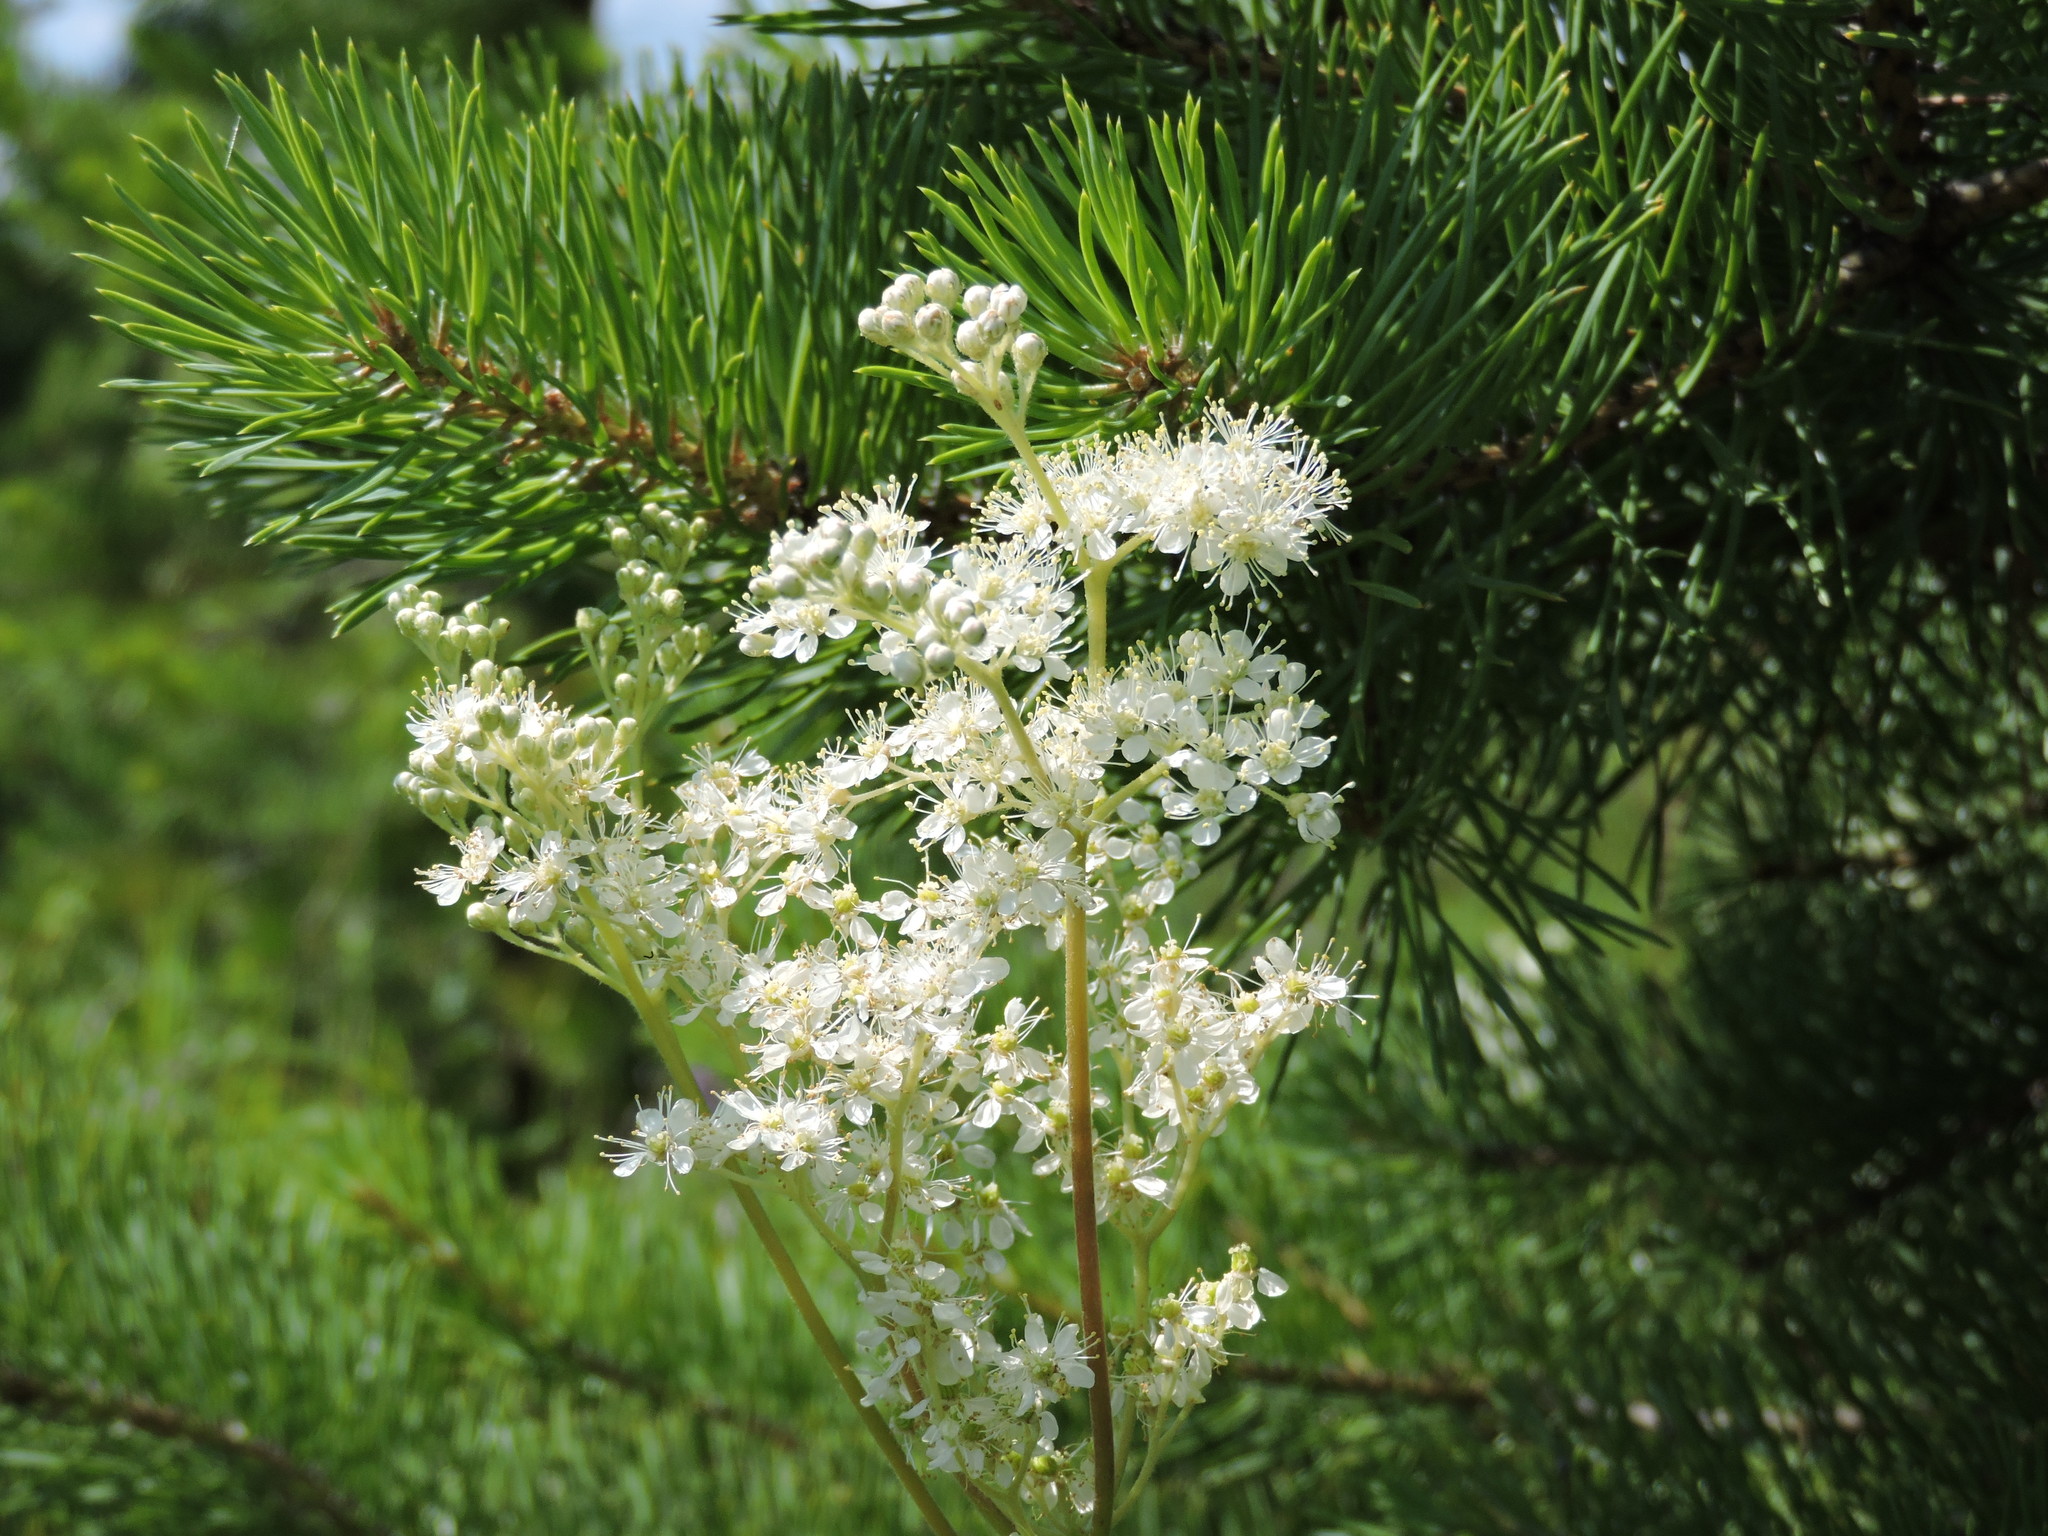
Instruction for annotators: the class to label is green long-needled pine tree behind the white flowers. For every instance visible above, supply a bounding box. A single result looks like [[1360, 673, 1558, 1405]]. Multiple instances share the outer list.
[[12, 0, 2048, 1532]]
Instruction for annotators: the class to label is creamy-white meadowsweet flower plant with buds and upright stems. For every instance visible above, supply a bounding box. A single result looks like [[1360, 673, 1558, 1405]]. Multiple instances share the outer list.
[[391, 270, 1352, 1534]]
